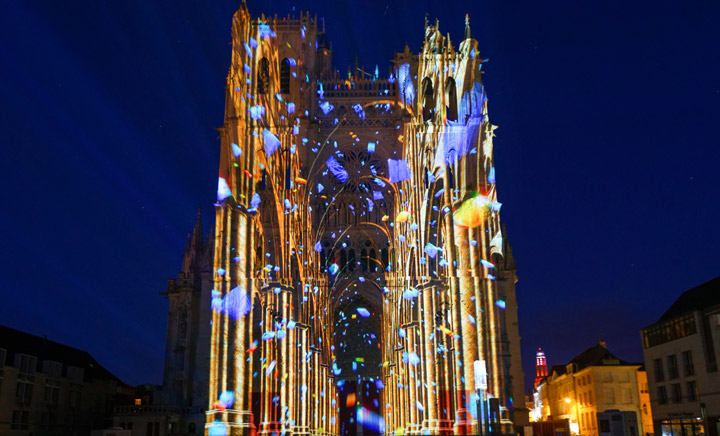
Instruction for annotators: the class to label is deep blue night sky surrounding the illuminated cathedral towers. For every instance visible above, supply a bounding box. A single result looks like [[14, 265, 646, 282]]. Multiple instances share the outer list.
[[0, 0, 720, 392]]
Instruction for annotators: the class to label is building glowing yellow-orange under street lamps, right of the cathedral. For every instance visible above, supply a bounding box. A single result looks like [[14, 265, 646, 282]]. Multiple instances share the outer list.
[[533, 341, 653, 436]]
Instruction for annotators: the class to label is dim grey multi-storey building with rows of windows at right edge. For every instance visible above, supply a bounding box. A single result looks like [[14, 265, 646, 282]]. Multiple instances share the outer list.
[[641, 277, 720, 436]]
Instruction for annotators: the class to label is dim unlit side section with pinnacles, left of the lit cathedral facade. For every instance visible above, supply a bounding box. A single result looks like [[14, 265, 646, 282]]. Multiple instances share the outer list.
[[113, 210, 213, 436]]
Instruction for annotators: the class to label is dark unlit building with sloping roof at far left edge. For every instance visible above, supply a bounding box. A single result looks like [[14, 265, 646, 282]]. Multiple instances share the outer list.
[[0, 326, 132, 436]]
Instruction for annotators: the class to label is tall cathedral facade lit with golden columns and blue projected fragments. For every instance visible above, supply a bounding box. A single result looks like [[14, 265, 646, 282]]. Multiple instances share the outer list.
[[206, 4, 523, 435]]
